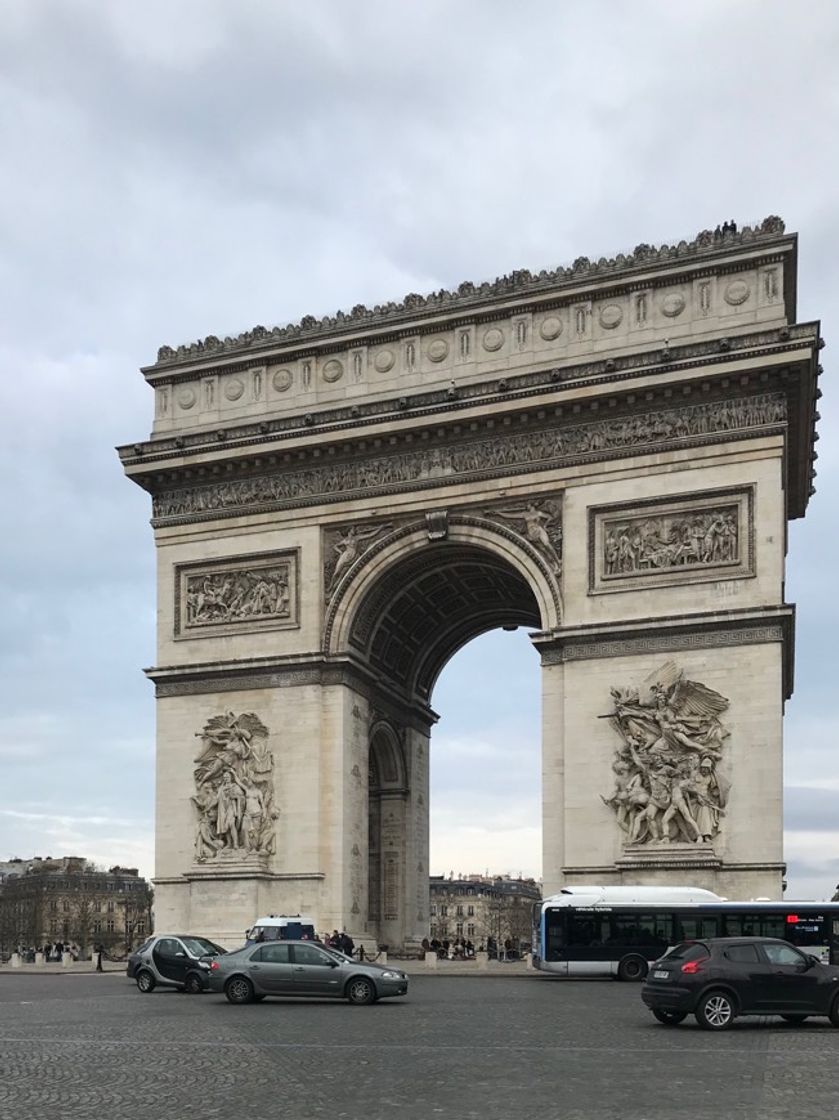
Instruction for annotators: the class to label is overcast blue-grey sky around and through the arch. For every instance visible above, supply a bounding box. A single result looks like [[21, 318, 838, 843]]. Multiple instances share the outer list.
[[0, 0, 839, 897]]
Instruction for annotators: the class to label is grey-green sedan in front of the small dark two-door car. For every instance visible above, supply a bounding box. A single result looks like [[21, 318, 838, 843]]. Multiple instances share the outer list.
[[208, 941, 408, 1004]]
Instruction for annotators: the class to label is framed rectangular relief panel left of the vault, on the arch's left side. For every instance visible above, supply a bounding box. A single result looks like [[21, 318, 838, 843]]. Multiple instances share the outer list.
[[175, 549, 300, 640]]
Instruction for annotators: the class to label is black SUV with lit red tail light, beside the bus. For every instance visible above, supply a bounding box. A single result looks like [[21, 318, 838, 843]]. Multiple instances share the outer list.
[[641, 937, 839, 1030]]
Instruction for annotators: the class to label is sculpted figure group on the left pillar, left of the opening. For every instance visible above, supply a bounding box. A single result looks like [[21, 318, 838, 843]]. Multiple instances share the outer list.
[[192, 711, 279, 864]]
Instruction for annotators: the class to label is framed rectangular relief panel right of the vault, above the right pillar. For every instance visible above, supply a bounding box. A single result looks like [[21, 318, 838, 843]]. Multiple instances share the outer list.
[[588, 486, 755, 595]]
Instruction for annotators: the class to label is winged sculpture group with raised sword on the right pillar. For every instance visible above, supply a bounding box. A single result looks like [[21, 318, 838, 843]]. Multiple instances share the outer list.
[[602, 662, 729, 844]]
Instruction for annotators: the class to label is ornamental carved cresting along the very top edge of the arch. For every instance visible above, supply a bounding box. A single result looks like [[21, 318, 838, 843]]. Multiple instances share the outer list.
[[148, 216, 784, 370]]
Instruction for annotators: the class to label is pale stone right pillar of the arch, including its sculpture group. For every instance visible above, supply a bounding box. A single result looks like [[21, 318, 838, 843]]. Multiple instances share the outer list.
[[543, 619, 785, 899]]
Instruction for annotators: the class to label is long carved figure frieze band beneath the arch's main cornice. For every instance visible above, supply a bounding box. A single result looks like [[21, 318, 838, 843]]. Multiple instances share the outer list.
[[148, 393, 786, 526]]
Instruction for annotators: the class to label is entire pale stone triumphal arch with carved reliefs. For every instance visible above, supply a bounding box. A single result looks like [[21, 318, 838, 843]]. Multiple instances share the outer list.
[[120, 218, 820, 945]]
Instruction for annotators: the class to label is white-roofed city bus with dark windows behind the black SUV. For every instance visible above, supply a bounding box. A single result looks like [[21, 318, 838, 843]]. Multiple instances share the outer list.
[[532, 886, 839, 980]]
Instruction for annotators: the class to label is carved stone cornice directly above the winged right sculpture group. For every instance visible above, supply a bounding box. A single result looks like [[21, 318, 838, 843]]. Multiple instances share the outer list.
[[532, 604, 795, 700]]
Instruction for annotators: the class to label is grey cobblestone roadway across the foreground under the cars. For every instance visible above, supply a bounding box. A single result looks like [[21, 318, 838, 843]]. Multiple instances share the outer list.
[[0, 973, 839, 1120]]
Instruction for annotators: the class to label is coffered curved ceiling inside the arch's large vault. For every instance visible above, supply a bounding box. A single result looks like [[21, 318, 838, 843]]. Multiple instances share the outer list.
[[349, 541, 542, 701]]
